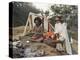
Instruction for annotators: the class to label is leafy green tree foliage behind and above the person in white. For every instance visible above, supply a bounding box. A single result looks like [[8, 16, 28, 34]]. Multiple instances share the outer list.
[[50, 4, 78, 29]]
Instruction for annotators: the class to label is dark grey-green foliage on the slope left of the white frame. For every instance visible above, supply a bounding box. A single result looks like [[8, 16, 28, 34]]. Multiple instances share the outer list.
[[13, 2, 40, 27]]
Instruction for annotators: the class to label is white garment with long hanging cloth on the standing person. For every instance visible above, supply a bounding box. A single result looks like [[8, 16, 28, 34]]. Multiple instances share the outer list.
[[55, 23, 72, 54]]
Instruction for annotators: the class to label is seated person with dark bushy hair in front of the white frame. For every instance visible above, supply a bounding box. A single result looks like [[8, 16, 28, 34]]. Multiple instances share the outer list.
[[32, 17, 43, 41]]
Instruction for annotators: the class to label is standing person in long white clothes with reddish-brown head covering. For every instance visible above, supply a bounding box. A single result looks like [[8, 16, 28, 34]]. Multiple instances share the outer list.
[[55, 16, 72, 54]]
